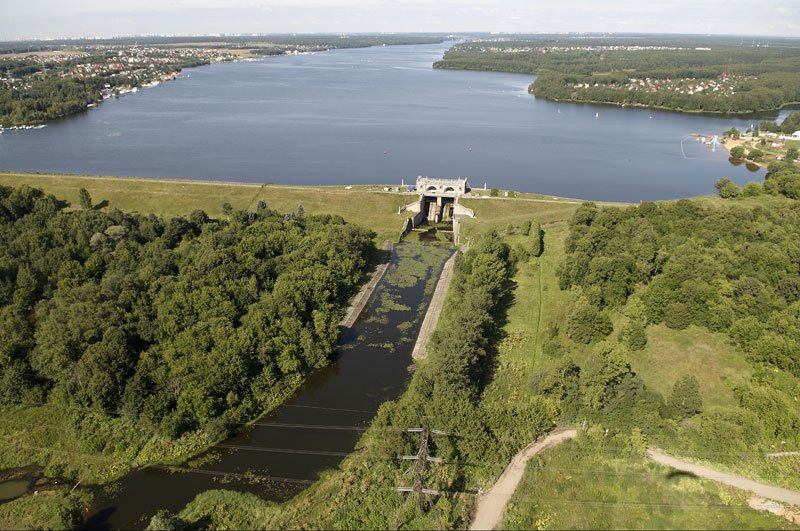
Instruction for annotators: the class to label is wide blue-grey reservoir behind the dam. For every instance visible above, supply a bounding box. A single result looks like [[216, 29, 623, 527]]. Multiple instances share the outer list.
[[0, 44, 788, 202]]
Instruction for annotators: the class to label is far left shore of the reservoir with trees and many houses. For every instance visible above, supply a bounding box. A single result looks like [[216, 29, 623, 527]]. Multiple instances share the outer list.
[[0, 35, 445, 126]]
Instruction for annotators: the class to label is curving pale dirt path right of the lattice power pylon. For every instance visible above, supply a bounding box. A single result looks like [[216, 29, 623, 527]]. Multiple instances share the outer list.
[[469, 429, 578, 530]]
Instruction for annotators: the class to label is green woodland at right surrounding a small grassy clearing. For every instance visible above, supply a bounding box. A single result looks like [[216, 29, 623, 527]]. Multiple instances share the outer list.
[[552, 195, 800, 463]]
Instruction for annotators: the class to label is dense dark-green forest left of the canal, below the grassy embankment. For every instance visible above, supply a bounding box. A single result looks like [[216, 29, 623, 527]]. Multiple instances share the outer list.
[[0, 186, 374, 440]]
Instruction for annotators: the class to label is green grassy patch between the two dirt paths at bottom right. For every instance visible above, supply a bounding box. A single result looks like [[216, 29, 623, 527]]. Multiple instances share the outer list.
[[501, 441, 792, 529]]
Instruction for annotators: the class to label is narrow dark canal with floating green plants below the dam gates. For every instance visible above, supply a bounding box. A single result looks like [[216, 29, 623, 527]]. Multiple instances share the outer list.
[[84, 242, 452, 529]]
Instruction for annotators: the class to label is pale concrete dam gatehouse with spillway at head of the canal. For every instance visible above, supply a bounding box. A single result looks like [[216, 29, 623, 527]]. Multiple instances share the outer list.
[[400, 176, 475, 244]]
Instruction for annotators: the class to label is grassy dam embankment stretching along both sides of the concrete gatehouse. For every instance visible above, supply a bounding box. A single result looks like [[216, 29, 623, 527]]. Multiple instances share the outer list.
[[0, 172, 592, 242]]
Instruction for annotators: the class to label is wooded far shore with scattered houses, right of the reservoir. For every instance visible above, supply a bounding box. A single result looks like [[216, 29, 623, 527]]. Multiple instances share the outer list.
[[434, 37, 800, 113]]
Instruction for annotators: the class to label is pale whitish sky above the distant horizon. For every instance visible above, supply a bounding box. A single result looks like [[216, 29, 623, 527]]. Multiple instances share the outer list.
[[0, 0, 800, 40]]
